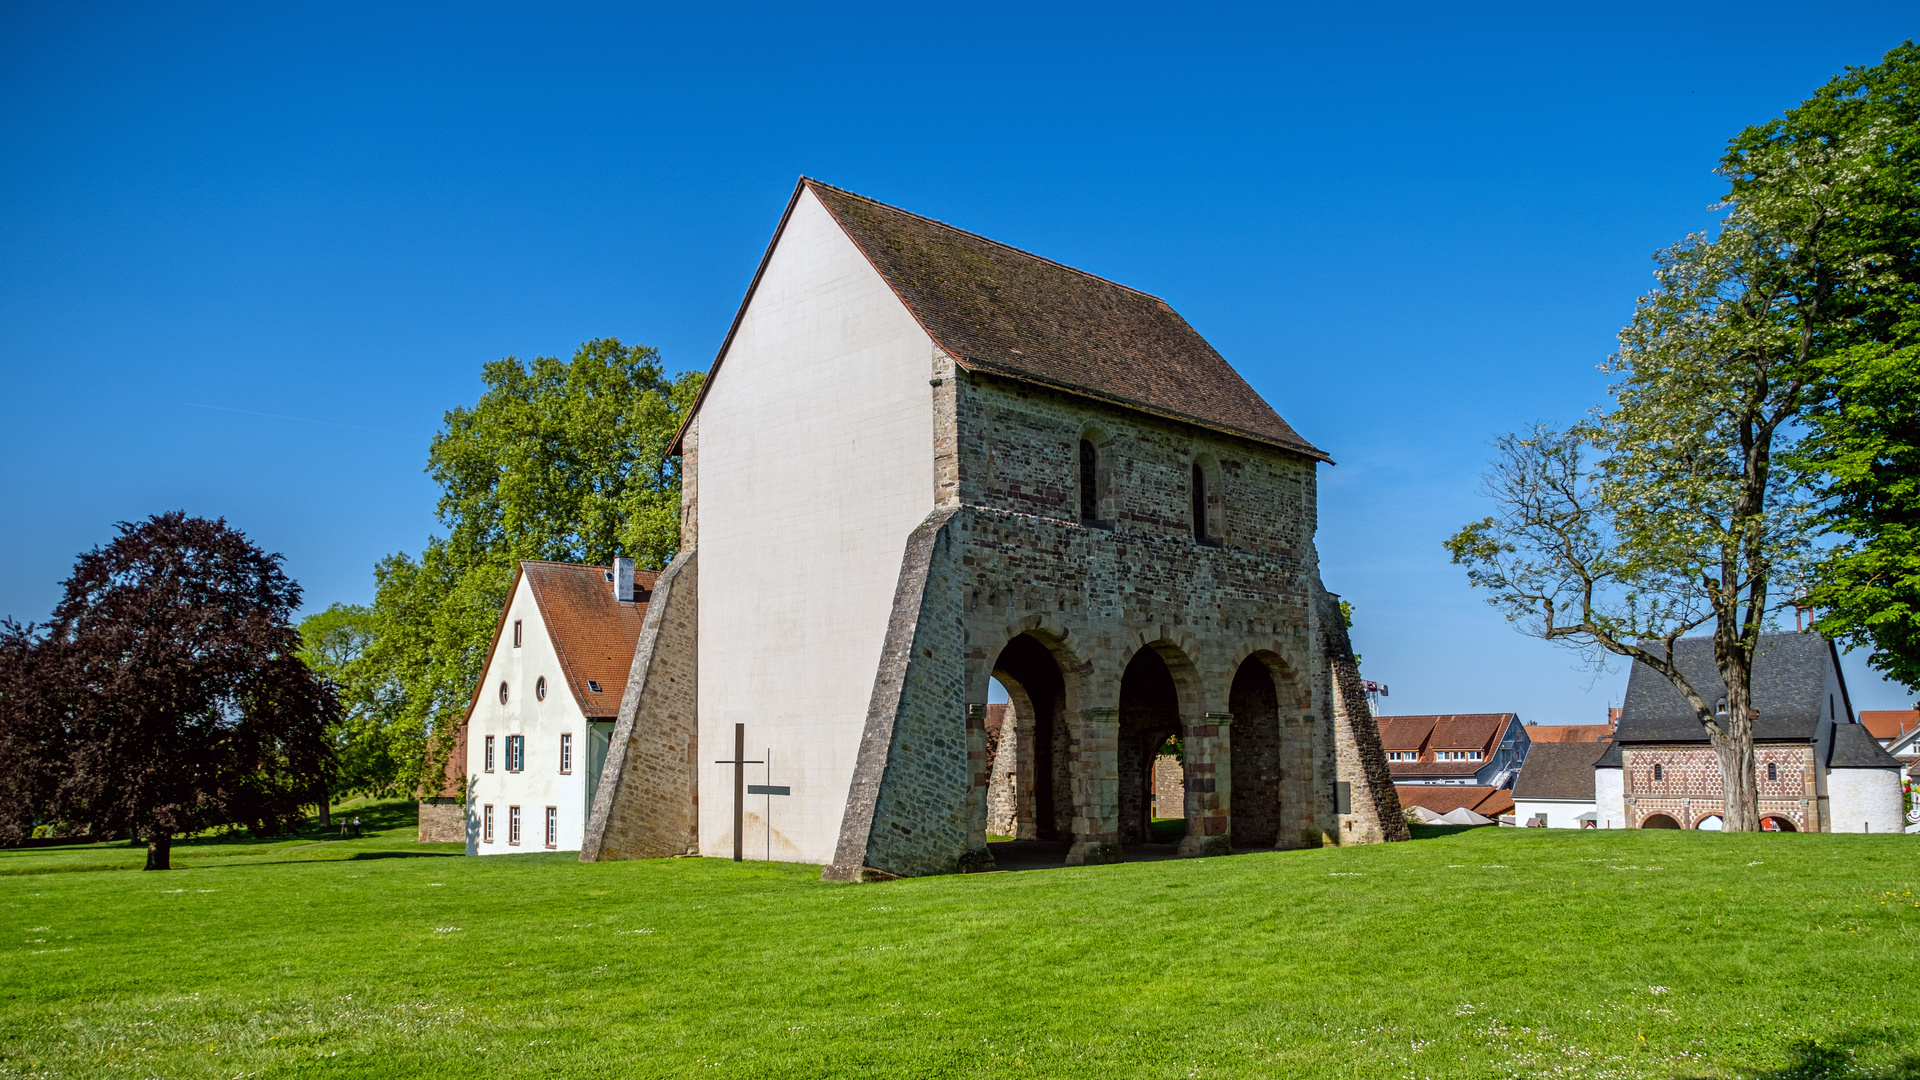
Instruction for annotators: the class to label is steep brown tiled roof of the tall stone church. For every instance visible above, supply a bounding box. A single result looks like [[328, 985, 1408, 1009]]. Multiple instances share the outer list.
[[676, 177, 1327, 459]]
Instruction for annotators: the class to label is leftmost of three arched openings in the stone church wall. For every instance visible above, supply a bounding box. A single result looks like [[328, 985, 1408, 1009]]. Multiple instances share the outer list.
[[987, 634, 1073, 840]]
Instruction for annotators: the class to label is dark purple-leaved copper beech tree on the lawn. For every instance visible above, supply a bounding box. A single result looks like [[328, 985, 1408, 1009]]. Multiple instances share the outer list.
[[0, 513, 338, 871]]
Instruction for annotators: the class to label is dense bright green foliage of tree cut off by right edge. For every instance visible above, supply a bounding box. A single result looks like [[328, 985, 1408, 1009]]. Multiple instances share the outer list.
[[1724, 42, 1920, 690]]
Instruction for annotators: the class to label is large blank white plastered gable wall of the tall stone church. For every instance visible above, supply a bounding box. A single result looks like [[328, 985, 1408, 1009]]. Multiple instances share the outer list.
[[697, 182, 933, 863]]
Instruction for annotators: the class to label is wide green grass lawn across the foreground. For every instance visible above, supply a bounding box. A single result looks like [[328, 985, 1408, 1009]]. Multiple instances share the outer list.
[[0, 807, 1920, 1078]]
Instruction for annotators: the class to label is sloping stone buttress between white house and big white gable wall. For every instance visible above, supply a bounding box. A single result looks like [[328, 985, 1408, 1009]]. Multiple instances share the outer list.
[[580, 548, 699, 863]]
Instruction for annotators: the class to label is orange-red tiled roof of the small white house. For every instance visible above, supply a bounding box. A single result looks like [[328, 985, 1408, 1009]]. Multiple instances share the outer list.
[[520, 559, 660, 717]]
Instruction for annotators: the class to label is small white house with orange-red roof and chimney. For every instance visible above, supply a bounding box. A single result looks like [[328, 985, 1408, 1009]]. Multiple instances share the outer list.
[[465, 559, 657, 855]]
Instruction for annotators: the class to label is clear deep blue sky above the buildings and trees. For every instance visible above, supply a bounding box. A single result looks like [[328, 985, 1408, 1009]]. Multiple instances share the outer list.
[[0, 2, 1920, 723]]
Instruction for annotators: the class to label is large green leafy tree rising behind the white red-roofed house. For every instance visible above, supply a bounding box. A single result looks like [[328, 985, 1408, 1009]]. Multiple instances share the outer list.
[[363, 338, 703, 790]]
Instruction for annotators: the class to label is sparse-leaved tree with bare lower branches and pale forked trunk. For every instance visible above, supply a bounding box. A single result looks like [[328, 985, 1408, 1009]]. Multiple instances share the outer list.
[[1448, 46, 1912, 830]]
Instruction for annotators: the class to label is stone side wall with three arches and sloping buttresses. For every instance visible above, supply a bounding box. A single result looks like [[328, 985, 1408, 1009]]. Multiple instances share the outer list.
[[826, 368, 1405, 880]]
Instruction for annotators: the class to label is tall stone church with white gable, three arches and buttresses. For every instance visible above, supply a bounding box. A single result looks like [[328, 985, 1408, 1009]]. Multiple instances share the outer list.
[[582, 179, 1407, 880]]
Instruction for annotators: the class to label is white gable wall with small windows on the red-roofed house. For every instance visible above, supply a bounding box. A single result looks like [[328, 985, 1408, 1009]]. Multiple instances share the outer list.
[[467, 575, 587, 855]]
